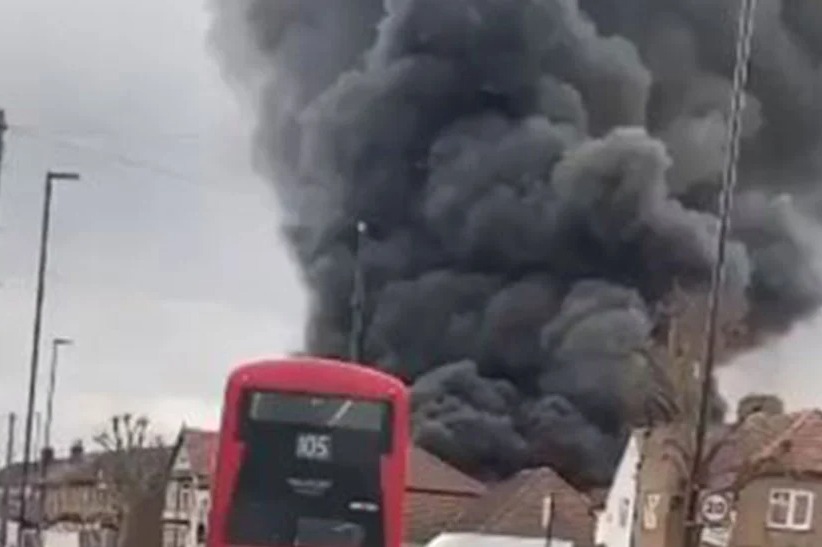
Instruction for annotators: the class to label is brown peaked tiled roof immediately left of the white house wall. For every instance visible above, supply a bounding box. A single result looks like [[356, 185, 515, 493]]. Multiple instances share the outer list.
[[450, 467, 594, 547]]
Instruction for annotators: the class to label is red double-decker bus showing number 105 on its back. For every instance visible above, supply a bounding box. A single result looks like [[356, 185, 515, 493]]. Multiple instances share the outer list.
[[207, 358, 409, 547]]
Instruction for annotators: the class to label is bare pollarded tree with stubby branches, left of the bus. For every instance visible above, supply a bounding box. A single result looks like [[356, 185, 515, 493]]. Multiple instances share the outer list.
[[94, 414, 170, 547]]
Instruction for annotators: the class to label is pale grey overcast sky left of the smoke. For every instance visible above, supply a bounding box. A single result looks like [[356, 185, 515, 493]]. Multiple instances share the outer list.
[[0, 0, 305, 449]]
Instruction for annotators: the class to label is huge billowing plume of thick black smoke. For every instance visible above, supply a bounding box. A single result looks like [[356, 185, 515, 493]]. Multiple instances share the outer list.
[[213, 0, 822, 481]]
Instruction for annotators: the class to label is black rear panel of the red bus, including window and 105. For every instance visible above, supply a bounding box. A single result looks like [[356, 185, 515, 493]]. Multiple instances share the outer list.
[[226, 391, 392, 547]]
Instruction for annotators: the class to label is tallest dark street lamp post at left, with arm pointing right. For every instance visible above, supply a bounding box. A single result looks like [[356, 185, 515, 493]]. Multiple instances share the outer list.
[[17, 171, 80, 545]]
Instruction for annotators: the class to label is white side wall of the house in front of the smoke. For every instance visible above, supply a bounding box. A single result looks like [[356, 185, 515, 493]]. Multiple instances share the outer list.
[[594, 429, 646, 547]]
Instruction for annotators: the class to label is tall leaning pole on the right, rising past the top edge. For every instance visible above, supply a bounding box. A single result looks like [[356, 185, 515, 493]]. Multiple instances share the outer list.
[[683, 0, 756, 547]]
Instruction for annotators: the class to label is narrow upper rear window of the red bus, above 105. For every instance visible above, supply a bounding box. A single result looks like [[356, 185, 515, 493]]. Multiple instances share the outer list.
[[247, 391, 390, 433]]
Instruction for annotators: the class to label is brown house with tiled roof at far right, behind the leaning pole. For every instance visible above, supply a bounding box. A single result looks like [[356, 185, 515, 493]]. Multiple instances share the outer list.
[[634, 396, 822, 547]]
